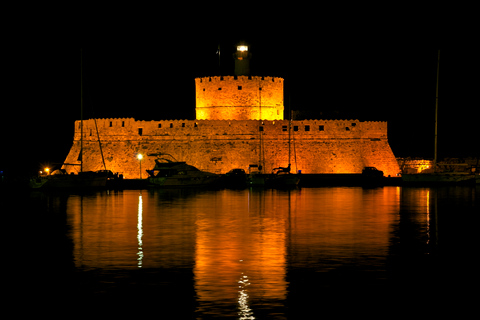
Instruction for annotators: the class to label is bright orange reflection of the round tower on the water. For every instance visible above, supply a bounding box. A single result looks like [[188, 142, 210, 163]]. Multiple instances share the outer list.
[[194, 190, 289, 314]]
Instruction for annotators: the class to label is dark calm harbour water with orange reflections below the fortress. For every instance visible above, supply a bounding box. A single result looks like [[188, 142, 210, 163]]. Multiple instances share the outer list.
[[2, 187, 480, 319]]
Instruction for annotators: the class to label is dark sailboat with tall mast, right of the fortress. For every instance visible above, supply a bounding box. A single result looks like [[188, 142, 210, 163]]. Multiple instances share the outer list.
[[402, 50, 477, 185]]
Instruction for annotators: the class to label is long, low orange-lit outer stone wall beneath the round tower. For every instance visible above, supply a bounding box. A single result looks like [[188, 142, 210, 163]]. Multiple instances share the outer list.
[[64, 118, 400, 178]]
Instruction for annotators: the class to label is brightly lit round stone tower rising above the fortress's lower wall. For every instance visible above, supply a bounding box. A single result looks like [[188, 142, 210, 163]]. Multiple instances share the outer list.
[[195, 76, 284, 120]]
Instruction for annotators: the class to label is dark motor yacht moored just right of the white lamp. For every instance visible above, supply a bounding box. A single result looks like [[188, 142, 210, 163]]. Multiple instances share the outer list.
[[147, 158, 220, 188]]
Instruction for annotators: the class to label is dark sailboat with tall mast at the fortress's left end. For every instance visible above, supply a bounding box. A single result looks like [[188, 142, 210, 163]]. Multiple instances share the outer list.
[[29, 49, 109, 189]]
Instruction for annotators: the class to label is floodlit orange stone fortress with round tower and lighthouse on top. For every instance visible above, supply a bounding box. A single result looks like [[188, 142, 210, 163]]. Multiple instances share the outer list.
[[63, 46, 400, 179]]
